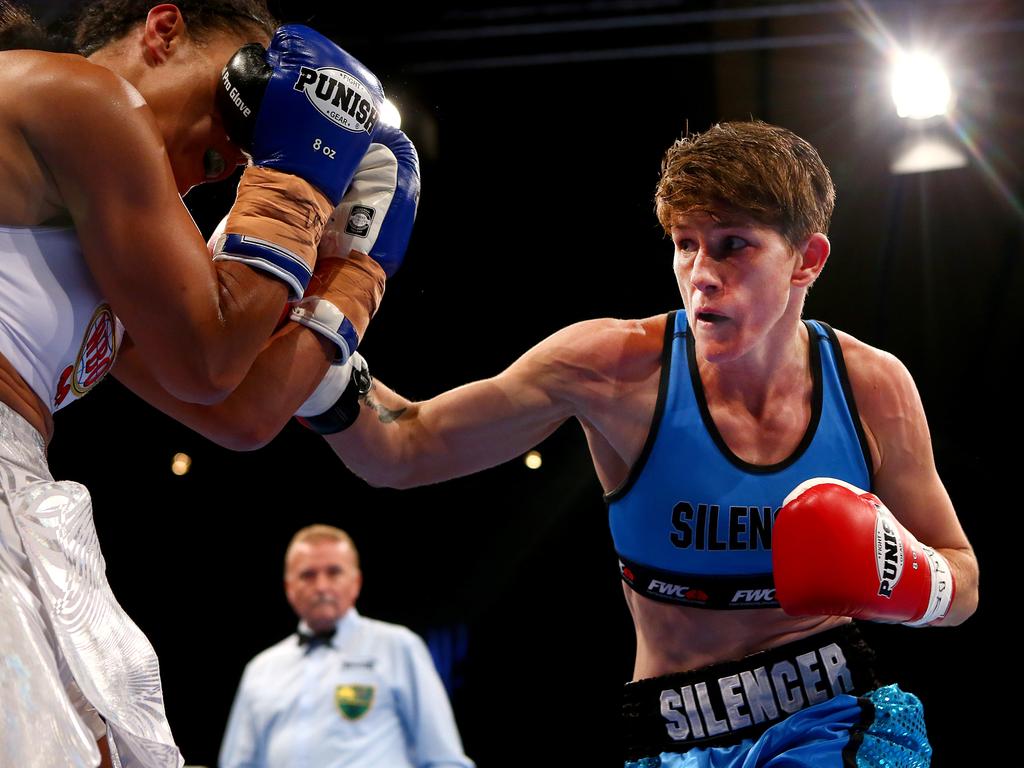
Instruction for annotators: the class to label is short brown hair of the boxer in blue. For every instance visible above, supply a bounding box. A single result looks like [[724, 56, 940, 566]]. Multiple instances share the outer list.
[[654, 121, 836, 246]]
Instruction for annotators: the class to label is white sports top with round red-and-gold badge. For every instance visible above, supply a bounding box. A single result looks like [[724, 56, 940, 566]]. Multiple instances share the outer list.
[[0, 226, 123, 413]]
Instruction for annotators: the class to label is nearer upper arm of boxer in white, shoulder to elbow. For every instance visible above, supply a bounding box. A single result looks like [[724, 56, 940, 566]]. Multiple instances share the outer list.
[[26, 62, 251, 397]]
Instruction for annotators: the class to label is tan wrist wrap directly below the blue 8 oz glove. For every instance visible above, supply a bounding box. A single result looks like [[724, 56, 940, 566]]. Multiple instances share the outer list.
[[224, 166, 334, 268]]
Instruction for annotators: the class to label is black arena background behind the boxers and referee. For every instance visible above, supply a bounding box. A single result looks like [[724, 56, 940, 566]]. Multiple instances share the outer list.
[[25, 0, 1024, 767]]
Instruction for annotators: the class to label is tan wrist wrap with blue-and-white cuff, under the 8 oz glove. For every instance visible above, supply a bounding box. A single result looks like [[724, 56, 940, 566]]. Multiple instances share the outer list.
[[213, 167, 334, 300]]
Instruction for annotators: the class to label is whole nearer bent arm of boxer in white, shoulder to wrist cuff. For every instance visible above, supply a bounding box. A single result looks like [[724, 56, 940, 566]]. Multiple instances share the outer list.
[[18, 57, 288, 402]]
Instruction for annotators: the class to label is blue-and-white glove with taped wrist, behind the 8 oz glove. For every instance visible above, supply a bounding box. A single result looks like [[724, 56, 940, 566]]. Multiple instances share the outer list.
[[291, 125, 420, 364]]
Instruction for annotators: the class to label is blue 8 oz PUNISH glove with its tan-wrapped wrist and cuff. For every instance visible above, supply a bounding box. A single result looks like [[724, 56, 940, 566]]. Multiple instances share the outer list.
[[214, 25, 384, 299]]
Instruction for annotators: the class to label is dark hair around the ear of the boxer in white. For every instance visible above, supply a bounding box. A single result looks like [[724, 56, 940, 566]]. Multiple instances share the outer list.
[[75, 0, 278, 56]]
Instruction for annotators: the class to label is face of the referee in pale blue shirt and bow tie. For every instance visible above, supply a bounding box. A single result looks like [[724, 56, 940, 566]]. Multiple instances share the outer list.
[[285, 540, 362, 632]]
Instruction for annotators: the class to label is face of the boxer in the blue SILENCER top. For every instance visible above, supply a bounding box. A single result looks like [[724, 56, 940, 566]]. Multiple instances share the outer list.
[[671, 212, 802, 362]]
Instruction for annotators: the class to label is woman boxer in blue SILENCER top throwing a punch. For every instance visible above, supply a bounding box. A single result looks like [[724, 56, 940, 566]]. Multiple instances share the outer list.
[[313, 123, 978, 768]]
